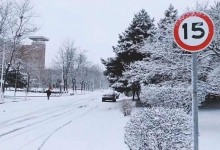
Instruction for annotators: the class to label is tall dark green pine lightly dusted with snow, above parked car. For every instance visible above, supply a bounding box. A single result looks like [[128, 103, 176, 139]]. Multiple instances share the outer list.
[[102, 9, 156, 91]]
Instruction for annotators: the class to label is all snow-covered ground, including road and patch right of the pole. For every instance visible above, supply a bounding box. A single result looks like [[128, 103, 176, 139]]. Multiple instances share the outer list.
[[0, 91, 220, 150]]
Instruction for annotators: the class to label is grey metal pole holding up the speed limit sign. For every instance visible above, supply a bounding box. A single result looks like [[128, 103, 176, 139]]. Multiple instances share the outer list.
[[192, 52, 199, 150]]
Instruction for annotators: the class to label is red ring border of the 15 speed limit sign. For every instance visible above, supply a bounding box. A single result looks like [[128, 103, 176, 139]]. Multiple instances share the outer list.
[[173, 11, 215, 52]]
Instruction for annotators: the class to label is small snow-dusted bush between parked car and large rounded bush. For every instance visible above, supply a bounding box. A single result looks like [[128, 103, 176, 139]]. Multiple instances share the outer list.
[[120, 100, 135, 116]]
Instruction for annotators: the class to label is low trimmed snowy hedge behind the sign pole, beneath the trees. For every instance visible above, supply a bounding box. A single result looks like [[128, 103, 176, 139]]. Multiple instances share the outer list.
[[140, 84, 207, 112]]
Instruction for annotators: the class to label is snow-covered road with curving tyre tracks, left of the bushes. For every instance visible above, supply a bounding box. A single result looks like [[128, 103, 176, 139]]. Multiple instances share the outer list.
[[0, 91, 129, 150]]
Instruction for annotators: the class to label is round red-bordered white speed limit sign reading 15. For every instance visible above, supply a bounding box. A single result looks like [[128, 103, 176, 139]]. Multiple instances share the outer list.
[[173, 11, 215, 52]]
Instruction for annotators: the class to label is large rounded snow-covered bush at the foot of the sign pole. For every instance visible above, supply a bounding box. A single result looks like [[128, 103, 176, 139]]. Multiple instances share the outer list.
[[125, 107, 192, 150]]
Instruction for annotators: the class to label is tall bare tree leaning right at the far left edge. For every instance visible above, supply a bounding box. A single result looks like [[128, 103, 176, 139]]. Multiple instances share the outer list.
[[0, 0, 38, 91]]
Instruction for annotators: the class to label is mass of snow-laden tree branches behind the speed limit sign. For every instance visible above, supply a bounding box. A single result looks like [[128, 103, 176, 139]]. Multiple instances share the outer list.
[[123, 4, 220, 104]]
